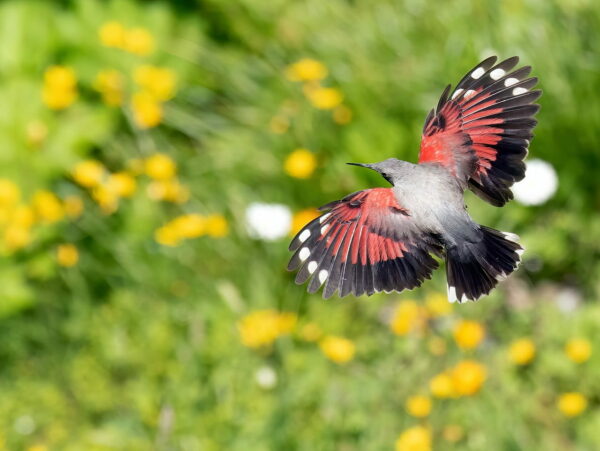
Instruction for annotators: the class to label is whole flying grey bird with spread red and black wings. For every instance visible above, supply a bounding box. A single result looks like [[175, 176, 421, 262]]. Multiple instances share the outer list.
[[287, 56, 542, 303]]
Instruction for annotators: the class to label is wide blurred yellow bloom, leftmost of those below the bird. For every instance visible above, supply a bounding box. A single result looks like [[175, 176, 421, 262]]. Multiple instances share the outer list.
[[237, 309, 297, 348]]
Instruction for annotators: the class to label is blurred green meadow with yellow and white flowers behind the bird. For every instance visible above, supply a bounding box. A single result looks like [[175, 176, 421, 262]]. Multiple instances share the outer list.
[[0, 0, 600, 451]]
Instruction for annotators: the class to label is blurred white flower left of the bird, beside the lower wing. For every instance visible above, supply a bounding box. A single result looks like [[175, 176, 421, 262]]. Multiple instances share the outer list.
[[246, 202, 292, 241]]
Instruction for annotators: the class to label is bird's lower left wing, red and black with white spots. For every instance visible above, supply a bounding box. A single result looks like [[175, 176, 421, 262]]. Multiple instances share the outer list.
[[288, 188, 441, 298]]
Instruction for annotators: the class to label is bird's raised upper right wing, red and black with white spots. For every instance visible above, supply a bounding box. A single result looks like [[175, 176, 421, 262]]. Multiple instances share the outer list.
[[419, 56, 542, 206]]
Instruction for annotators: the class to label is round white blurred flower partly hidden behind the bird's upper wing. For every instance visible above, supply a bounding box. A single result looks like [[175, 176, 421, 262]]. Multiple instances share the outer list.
[[512, 160, 558, 205]]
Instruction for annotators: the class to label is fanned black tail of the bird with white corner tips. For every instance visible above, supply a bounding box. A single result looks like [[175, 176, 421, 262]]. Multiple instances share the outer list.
[[446, 226, 523, 302]]
